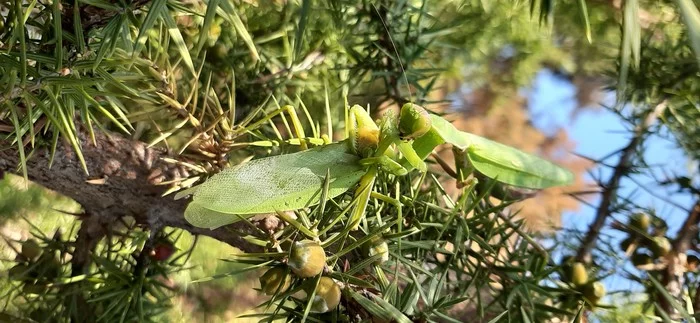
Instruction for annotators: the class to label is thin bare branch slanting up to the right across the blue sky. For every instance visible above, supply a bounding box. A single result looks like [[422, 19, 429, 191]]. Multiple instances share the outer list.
[[576, 100, 667, 263]]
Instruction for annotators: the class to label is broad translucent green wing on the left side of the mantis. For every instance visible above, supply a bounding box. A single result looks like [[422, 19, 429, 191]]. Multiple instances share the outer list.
[[185, 143, 365, 228]]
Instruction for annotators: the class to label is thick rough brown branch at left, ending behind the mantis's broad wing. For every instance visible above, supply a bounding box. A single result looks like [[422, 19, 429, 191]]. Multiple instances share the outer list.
[[0, 131, 260, 253]]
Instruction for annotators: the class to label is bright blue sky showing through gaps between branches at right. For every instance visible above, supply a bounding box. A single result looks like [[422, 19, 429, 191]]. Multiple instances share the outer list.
[[528, 70, 693, 298]]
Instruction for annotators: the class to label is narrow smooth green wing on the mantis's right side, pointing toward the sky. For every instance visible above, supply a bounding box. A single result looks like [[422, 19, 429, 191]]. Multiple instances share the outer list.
[[426, 115, 574, 189]]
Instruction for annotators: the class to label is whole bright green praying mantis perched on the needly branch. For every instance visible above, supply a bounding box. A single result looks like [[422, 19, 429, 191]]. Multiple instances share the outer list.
[[176, 103, 573, 229]]
